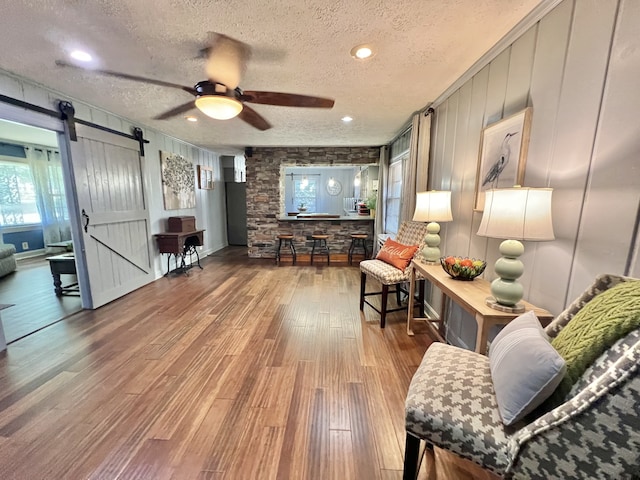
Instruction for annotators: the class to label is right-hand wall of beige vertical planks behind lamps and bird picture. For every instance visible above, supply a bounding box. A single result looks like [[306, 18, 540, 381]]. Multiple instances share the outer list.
[[429, 0, 640, 346]]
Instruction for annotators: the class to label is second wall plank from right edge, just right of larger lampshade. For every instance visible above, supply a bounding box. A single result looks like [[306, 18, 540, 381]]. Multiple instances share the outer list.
[[531, 0, 617, 305]]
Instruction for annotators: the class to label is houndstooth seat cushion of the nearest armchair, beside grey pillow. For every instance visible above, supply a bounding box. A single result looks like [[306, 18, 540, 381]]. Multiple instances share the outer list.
[[405, 343, 510, 474]]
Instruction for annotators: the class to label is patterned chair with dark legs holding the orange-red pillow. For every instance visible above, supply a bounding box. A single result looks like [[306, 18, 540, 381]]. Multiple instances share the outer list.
[[360, 222, 427, 328]]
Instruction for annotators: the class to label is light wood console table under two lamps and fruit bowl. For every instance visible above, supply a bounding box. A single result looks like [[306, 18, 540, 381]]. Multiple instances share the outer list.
[[407, 260, 553, 354]]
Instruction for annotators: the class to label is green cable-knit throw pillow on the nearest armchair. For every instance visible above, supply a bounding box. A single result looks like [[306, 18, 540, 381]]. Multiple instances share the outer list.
[[549, 280, 640, 407]]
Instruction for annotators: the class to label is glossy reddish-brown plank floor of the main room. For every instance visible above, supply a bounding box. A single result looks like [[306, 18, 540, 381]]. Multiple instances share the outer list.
[[0, 248, 442, 480]]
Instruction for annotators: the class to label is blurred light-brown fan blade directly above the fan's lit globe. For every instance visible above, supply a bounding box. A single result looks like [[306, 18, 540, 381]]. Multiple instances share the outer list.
[[205, 33, 251, 90]]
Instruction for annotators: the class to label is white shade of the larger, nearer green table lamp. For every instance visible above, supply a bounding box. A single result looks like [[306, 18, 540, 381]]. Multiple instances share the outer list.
[[478, 187, 555, 241]]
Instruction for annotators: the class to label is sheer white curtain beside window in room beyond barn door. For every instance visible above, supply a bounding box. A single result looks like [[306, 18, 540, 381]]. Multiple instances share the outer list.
[[25, 147, 71, 252]]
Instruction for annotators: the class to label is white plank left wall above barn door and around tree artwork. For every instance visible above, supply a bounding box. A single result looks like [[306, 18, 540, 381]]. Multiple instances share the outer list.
[[0, 67, 227, 278]]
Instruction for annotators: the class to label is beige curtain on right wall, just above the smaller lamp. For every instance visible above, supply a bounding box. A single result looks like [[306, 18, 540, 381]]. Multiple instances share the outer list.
[[400, 109, 433, 222]]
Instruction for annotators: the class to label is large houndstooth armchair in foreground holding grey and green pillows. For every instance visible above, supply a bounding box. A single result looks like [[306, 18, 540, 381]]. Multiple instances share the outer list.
[[404, 275, 640, 480]]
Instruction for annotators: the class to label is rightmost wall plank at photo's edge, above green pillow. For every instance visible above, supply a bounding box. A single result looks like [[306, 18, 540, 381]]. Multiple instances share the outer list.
[[572, 0, 640, 300]]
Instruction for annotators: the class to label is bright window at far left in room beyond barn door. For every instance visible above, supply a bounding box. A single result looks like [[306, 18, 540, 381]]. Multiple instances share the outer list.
[[0, 160, 41, 226]]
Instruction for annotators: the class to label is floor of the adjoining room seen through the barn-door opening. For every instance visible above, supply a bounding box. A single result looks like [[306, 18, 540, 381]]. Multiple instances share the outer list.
[[0, 256, 82, 342]]
